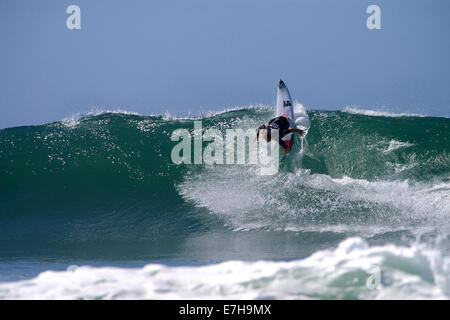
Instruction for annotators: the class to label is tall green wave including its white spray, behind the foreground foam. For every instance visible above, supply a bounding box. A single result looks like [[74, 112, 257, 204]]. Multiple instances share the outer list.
[[0, 107, 450, 261]]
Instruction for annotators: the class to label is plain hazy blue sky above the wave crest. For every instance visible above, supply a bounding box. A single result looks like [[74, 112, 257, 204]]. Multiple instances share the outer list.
[[0, 0, 450, 128]]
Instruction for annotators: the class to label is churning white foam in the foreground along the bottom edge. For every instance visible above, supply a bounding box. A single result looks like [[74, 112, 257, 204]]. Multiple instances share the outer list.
[[0, 238, 450, 299]]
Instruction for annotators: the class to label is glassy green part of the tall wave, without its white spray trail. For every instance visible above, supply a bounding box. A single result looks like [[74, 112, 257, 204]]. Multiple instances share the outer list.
[[0, 108, 450, 255]]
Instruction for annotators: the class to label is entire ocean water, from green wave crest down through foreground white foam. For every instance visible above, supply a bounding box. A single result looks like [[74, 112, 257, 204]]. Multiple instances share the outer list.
[[0, 105, 450, 299]]
